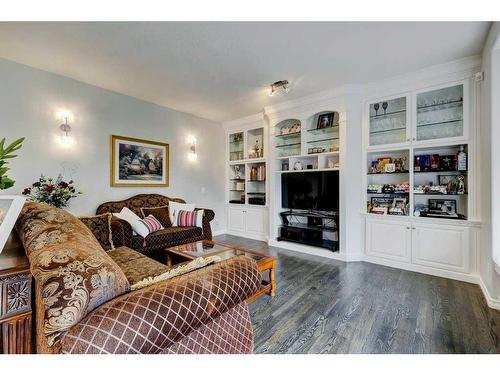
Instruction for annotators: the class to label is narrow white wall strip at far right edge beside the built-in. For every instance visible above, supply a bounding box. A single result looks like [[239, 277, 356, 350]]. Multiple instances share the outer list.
[[479, 22, 500, 306]]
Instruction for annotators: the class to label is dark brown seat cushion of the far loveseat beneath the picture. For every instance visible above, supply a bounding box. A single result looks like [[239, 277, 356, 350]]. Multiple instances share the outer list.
[[132, 227, 203, 250]]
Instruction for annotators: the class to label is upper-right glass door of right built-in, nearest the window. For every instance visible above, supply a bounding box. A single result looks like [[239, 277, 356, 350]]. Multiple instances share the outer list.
[[417, 85, 464, 141]]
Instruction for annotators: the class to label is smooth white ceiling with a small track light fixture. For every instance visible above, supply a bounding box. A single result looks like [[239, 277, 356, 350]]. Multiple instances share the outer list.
[[0, 22, 490, 121]]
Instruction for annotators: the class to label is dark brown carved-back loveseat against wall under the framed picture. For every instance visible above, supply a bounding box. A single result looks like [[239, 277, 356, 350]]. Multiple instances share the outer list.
[[96, 194, 215, 254]]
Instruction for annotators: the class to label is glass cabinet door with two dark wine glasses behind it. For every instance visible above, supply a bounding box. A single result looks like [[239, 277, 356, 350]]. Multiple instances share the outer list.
[[370, 97, 407, 146]]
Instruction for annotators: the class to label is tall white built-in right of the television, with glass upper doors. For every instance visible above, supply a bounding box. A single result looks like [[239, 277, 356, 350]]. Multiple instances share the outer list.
[[363, 73, 480, 280]]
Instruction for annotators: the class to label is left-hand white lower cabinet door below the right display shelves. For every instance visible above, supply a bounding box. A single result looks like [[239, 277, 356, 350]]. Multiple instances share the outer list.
[[366, 219, 411, 262]]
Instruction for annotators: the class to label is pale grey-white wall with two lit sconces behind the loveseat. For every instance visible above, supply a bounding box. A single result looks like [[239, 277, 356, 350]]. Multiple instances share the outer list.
[[0, 59, 225, 234]]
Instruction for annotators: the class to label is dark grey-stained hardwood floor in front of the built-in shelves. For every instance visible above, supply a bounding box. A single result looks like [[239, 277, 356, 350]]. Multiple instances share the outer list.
[[215, 235, 500, 353]]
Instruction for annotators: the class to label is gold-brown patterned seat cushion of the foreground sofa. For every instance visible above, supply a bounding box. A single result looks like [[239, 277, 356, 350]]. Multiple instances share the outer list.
[[108, 246, 170, 285]]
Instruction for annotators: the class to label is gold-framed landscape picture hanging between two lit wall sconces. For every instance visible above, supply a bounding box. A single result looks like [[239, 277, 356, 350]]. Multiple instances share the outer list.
[[111, 135, 169, 187]]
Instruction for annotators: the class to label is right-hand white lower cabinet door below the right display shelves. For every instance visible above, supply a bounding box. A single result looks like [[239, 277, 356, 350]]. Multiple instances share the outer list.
[[412, 224, 469, 272]]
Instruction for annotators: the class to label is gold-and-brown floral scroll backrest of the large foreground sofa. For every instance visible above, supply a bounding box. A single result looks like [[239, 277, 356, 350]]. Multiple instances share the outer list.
[[16, 202, 130, 346]]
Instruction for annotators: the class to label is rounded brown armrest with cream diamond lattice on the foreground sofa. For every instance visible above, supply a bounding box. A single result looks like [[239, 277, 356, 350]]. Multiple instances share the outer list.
[[61, 256, 262, 354]]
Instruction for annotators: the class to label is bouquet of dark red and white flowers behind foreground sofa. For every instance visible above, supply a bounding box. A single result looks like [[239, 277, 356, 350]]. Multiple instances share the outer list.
[[23, 174, 82, 208]]
